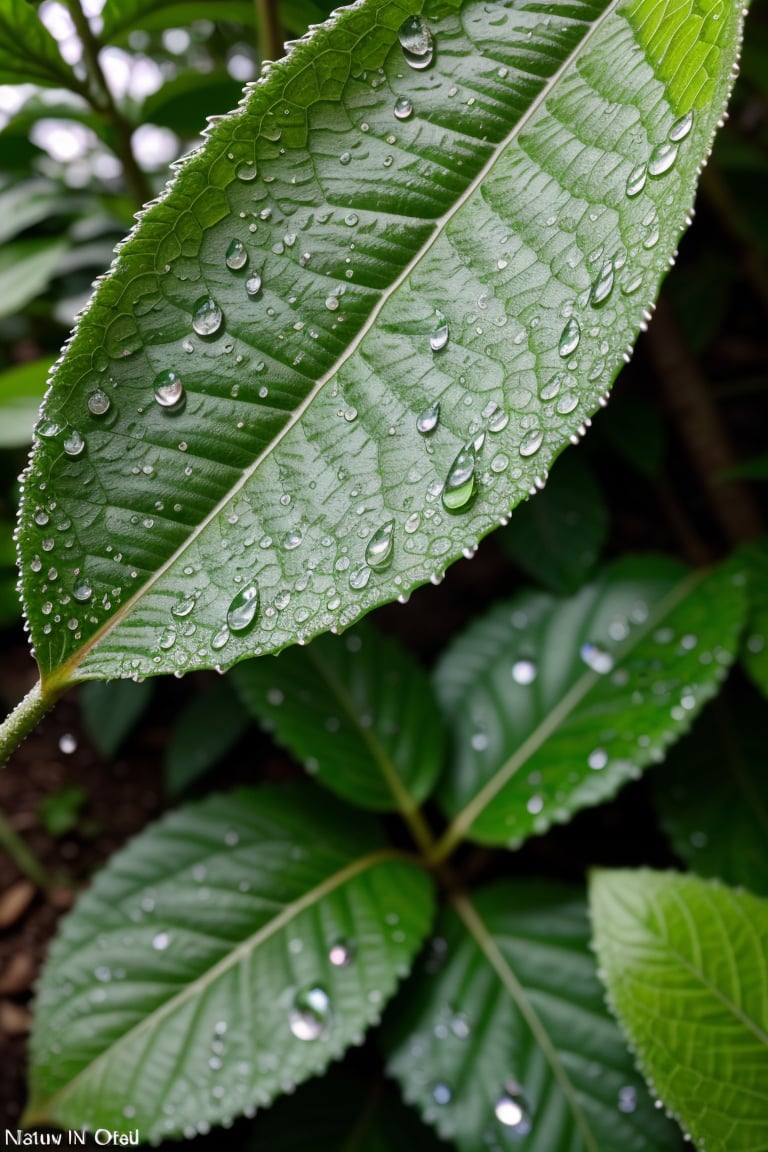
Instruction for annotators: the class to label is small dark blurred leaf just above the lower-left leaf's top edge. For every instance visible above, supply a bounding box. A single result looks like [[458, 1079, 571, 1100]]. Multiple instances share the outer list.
[[164, 677, 251, 796]]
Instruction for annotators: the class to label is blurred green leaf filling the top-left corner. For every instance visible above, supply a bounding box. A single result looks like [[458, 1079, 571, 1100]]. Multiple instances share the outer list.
[[0, 0, 82, 92]]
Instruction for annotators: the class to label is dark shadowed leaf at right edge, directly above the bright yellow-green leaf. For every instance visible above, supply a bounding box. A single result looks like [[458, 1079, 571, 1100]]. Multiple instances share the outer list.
[[654, 696, 768, 895]]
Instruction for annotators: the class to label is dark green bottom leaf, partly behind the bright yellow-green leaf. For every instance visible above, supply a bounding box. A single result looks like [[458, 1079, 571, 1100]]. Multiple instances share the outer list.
[[388, 880, 679, 1152]]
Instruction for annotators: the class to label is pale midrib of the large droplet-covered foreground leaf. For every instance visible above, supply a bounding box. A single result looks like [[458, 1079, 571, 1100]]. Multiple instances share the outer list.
[[41, 0, 623, 685]]
